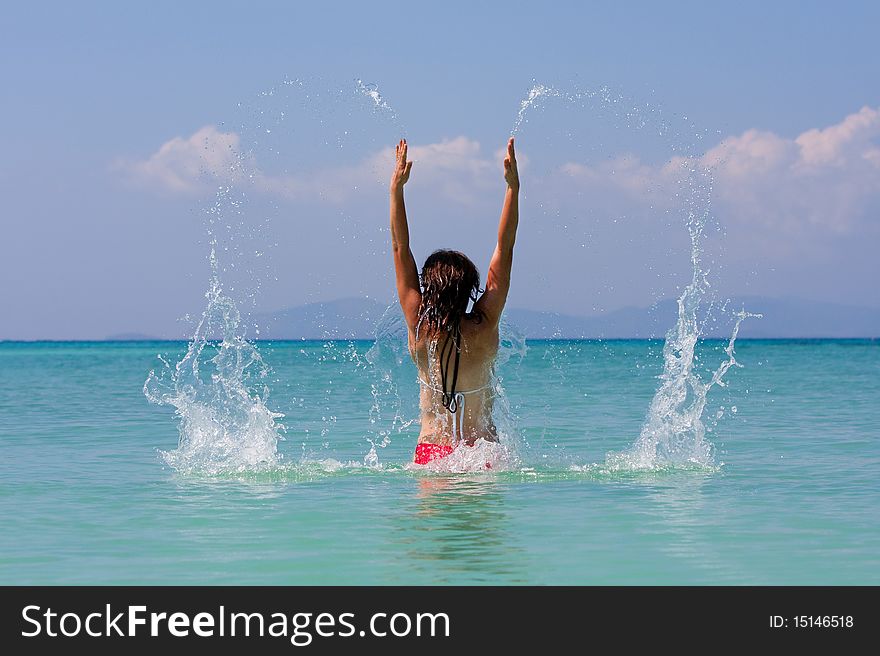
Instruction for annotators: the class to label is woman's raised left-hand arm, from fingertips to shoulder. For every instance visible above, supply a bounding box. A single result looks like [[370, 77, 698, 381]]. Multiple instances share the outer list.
[[389, 139, 422, 328]]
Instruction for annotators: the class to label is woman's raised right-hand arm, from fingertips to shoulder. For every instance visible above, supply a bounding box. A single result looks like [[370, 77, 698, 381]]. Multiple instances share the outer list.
[[475, 137, 519, 324]]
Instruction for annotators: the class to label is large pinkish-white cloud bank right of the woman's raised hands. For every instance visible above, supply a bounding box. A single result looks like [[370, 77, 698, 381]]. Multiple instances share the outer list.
[[560, 107, 880, 240]]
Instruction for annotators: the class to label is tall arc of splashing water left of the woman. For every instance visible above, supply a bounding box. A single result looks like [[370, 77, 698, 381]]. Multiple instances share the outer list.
[[144, 78, 406, 474]]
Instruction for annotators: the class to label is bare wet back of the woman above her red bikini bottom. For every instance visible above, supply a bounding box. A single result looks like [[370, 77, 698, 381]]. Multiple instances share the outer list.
[[409, 319, 498, 446]]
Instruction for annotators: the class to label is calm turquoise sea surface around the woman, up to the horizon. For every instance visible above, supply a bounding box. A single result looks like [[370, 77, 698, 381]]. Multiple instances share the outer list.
[[0, 340, 880, 585]]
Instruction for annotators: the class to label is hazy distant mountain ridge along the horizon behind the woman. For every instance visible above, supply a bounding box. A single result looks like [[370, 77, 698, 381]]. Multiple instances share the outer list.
[[253, 296, 880, 339]]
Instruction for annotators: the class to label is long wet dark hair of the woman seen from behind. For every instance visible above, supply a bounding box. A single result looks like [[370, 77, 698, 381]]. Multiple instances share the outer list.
[[419, 249, 483, 413]]
